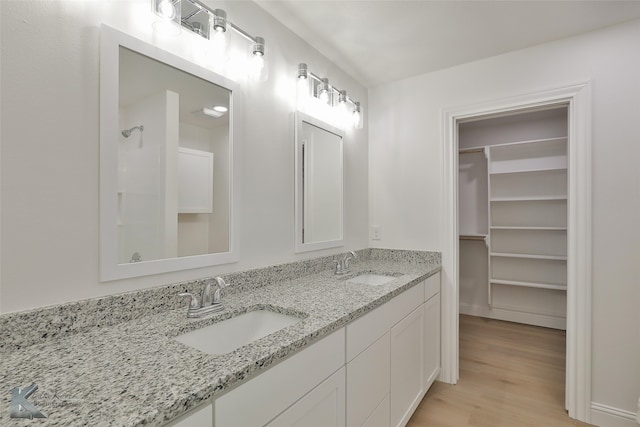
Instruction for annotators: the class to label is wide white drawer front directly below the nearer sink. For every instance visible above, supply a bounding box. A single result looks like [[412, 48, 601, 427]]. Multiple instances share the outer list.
[[214, 328, 345, 427]]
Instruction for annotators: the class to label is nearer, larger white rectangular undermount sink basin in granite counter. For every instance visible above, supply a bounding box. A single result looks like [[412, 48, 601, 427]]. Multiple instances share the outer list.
[[174, 310, 302, 354]]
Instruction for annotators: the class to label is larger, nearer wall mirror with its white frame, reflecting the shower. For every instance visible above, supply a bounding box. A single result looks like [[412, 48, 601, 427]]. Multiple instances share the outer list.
[[100, 25, 241, 281]]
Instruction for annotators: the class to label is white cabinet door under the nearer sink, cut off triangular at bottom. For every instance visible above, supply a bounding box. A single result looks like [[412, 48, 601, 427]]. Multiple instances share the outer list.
[[268, 367, 345, 427]]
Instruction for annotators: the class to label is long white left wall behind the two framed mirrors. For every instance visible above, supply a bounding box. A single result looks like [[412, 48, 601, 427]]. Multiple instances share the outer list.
[[0, 0, 368, 313]]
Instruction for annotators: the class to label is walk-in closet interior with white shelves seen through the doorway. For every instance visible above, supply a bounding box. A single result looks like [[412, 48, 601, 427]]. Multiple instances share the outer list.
[[458, 105, 568, 329]]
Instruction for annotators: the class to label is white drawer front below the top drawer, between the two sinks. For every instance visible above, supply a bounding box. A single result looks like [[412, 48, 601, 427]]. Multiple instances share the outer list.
[[347, 332, 390, 427]]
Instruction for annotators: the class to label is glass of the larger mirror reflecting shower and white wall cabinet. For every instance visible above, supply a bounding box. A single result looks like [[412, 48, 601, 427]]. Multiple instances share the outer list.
[[118, 47, 229, 263]]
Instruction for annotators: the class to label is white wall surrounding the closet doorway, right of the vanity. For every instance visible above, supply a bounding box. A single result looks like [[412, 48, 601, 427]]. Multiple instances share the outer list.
[[369, 21, 640, 422]]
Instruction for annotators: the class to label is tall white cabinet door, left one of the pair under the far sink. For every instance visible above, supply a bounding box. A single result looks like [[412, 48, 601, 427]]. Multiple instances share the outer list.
[[390, 304, 424, 426]]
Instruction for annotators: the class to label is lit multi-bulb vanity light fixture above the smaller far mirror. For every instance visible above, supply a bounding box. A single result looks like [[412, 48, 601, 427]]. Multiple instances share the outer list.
[[298, 62, 362, 129]]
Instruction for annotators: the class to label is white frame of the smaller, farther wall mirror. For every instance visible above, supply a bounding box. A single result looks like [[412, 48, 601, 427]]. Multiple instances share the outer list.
[[294, 111, 345, 253]]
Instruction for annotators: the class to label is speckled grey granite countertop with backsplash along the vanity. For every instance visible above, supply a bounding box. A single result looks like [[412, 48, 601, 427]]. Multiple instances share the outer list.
[[0, 249, 440, 426]]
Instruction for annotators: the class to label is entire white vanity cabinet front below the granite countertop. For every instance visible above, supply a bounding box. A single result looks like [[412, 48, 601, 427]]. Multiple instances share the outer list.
[[168, 273, 440, 427]]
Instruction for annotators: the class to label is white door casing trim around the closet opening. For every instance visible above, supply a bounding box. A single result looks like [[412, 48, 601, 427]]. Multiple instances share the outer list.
[[440, 82, 591, 422]]
